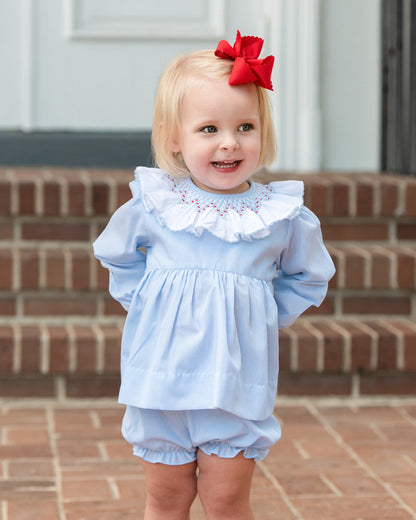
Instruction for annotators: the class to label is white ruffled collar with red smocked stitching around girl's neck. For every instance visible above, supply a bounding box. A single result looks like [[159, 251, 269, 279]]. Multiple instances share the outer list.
[[130, 167, 303, 242]]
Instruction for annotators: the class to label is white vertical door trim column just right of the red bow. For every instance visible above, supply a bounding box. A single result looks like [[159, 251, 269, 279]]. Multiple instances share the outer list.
[[265, 0, 322, 171]]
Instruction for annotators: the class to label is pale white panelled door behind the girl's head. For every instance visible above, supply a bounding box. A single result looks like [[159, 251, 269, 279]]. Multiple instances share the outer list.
[[0, 0, 270, 131]]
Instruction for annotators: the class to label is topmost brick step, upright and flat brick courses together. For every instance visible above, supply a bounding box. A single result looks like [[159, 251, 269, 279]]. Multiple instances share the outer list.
[[0, 168, 416, 244]]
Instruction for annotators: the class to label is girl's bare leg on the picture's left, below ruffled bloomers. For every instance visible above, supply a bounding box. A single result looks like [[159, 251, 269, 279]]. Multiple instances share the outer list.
[[142, 461, 197, 520]]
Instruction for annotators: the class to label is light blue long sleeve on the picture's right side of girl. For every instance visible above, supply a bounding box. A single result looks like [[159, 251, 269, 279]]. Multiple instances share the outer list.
[[273, 207, 335, 329]]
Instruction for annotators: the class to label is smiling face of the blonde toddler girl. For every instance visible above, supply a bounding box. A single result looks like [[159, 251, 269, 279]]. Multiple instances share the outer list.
[[172, 80, 261, 193]]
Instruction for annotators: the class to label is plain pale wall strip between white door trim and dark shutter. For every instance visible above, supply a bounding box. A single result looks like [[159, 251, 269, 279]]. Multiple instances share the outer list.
[[321, 0, 381, 171]]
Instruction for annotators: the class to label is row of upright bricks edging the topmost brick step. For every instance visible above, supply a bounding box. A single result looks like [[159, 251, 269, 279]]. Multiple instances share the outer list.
[[0, 167, 416, 218]]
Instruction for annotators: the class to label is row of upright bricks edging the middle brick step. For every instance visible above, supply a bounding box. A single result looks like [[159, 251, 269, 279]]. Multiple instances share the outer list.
[[0, 242, 416, 292]]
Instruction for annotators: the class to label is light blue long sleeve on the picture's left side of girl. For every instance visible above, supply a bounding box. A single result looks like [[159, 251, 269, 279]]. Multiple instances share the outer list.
[[93, 199, 146, 310]]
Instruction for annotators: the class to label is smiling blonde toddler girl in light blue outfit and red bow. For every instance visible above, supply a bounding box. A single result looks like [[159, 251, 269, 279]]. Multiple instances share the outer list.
[[94, 33, 334, 520]]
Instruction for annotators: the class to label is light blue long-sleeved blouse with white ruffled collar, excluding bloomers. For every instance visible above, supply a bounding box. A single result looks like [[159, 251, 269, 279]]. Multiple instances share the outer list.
[[94, 168, 335, 420]]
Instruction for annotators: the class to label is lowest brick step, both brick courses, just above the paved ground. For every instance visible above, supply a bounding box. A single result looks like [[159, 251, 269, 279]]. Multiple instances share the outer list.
[[0, 318, 416, 398]]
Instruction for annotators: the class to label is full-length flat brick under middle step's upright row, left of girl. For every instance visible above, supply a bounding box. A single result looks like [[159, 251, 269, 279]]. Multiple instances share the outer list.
[[24, 296, 97, 316]]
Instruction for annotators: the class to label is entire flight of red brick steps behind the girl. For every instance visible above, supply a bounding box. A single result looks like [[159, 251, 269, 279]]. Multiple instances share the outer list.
[[0, 168, 416, 397]]
